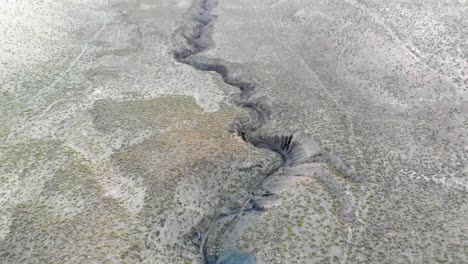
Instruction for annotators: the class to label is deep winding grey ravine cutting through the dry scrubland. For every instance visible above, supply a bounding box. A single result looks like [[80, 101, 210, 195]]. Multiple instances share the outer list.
[[173, 0, 354, 264]]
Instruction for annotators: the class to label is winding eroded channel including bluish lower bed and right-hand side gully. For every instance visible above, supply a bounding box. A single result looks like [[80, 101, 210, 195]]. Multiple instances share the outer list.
[[173, 0, 354, 264]]
